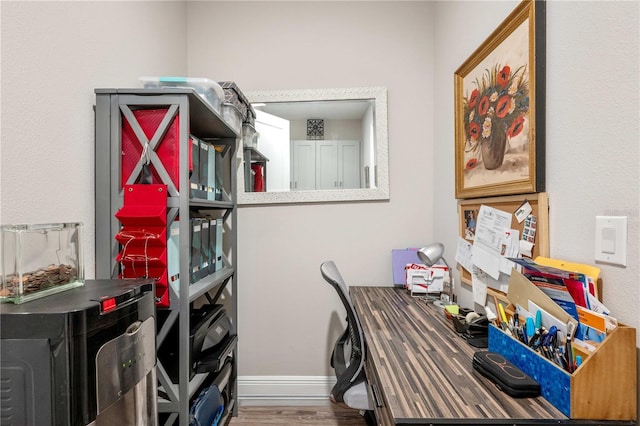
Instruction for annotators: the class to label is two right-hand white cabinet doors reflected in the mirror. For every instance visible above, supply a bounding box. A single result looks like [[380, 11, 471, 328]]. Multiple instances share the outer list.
[[316, 141, 360, 189]]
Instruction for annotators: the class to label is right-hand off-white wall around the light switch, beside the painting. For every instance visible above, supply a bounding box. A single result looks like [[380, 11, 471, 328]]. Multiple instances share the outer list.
[[547, 1, 640, 328]]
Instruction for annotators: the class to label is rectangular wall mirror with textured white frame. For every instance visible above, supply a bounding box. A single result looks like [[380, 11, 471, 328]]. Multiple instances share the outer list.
[[238, 87, 389, 205]]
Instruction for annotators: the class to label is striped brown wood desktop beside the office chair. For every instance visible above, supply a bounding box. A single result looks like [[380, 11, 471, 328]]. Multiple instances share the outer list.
[[350, 287, 635, 425]]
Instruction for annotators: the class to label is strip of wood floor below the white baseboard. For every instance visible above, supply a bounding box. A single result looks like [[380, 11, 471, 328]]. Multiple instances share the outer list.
[[229, 404, 367, 426]]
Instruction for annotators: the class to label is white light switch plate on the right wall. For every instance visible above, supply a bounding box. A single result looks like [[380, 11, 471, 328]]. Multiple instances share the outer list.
[[596, 216, 627, 266]]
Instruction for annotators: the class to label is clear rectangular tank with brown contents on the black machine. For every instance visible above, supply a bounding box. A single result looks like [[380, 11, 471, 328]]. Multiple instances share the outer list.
[[0, 223, 84, 303]]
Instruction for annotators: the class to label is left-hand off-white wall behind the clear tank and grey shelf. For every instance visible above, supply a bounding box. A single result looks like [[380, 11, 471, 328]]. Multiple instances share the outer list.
[[0, 1, 187, 278]]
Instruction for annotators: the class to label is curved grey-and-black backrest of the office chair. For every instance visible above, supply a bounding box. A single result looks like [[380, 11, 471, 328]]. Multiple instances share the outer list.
[[320, 261, 366, 383]]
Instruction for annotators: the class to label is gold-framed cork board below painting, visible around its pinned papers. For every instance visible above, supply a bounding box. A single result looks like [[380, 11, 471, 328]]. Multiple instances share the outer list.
[[458, 192, 549, 285]]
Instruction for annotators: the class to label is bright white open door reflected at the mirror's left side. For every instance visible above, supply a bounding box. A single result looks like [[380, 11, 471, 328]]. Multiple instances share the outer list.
[[256, 109, 291, 192]]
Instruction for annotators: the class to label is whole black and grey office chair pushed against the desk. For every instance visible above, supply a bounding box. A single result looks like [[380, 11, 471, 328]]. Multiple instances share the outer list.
[[320, 261, 375, 424]]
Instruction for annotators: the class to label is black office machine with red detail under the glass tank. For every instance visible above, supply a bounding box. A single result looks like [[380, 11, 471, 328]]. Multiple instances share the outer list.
[[0, 280, 158, 426]]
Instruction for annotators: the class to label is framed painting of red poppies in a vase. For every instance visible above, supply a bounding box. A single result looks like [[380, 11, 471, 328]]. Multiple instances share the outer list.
[[454, 0, 546, 199]]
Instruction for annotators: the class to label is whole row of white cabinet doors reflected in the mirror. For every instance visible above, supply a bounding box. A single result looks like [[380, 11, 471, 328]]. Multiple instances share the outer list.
[[291, 140, 361, 191]]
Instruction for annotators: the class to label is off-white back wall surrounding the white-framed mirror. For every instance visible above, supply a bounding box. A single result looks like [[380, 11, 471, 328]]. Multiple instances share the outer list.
[[188, 1, 433, 376]]
